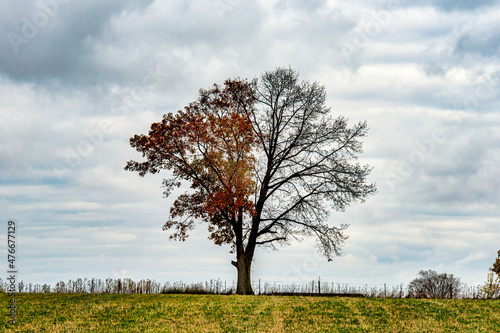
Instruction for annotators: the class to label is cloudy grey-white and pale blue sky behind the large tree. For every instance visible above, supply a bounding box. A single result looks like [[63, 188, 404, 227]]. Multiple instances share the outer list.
[[0, 0, 500, 286]]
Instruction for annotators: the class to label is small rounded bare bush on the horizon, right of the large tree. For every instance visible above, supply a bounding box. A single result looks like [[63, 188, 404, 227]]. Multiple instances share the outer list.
[[408, 270, 460, 298]]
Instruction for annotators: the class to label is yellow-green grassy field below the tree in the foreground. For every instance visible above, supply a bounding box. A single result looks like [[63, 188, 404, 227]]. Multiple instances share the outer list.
[[0, 293, 500, 333]]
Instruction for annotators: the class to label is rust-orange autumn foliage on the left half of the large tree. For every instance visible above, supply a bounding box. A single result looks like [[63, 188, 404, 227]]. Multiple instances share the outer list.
[[126, 80, 257, 245]]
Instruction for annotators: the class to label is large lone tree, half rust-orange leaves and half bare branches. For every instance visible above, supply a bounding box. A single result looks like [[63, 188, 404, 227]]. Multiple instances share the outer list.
[[125, 68, 376, 294]]
